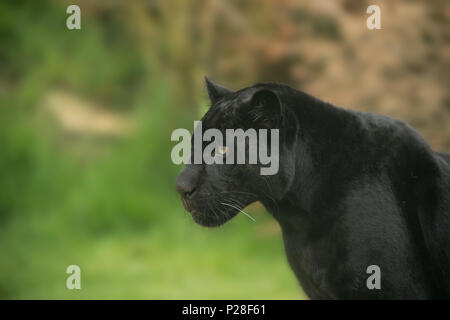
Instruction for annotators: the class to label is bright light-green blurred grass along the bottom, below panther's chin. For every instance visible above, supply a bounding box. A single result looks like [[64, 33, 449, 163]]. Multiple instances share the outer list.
[[0, 210, 302, 299]]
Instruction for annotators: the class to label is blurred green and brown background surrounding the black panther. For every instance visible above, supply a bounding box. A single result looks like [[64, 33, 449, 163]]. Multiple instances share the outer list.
[[0, 0, 450, 299]]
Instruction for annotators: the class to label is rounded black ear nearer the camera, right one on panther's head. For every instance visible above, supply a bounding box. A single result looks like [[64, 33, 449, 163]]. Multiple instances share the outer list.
[[247, 89, 281, 129]]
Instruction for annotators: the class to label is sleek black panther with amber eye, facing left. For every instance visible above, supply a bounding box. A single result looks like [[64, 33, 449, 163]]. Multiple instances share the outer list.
[[176, 79, 450, 299]]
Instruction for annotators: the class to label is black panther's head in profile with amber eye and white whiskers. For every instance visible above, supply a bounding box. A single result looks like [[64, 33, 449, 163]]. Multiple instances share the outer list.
[[176, 78, 298, 227]]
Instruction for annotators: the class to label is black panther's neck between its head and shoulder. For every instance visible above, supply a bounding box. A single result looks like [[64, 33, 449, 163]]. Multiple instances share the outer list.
[[271, 92, 365, 230]]
